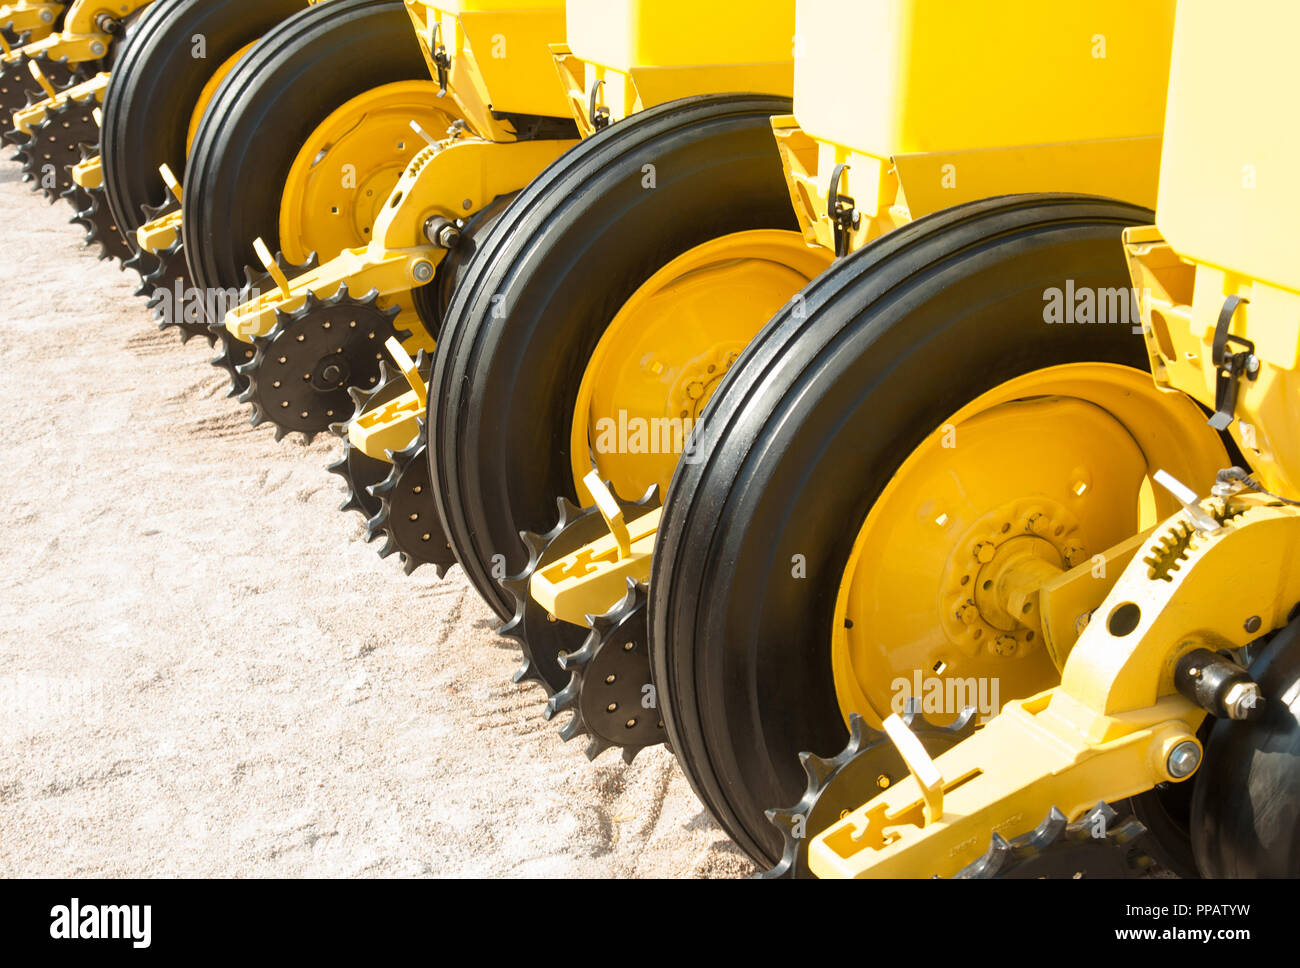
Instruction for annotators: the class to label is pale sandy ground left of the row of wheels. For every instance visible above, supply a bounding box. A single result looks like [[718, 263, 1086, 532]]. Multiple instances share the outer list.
[[0, 162, 751, 877]]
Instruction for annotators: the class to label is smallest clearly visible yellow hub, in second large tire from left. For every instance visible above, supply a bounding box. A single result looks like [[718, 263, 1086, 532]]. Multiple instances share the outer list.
[[280, 81, 459, 264]]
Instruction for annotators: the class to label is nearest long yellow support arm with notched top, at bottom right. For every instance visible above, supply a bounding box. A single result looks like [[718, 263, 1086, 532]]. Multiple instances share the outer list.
[[810, 495, 1300, 877]]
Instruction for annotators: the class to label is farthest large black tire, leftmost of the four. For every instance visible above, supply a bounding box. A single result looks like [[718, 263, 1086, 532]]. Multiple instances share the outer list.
[[100, 0, 307, 241]]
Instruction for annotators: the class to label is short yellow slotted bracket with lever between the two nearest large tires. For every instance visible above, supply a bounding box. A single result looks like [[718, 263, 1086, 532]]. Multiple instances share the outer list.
[[528, 498, 662, 626]]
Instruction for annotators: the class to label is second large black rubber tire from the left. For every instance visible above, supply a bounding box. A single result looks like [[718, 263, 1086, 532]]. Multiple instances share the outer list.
[[183, 0, 429, 290]]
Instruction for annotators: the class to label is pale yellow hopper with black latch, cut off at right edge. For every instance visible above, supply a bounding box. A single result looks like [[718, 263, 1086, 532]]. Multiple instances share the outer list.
[[1126, 3, 1300, 498]]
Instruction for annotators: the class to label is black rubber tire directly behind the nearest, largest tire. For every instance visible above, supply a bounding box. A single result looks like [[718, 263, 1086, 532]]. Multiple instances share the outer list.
[[429, 95, 797, 618]]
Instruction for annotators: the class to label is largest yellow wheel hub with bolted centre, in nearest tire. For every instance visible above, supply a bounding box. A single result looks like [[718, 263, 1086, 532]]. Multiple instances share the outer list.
[[832, 364, 1226, 726]]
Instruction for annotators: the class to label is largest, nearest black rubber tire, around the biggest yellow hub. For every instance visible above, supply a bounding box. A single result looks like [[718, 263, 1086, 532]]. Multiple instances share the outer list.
[[650, 195, 1152, 867]]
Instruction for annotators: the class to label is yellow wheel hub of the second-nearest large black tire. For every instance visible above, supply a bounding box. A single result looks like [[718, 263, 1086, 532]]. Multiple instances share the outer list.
[[572, 230, 831, 504]]
